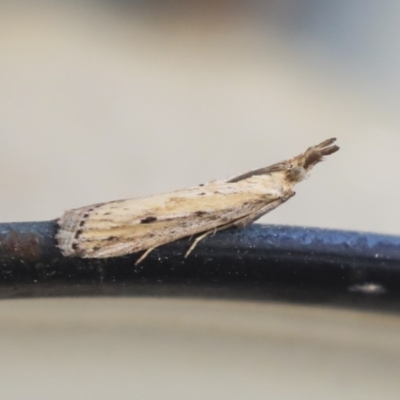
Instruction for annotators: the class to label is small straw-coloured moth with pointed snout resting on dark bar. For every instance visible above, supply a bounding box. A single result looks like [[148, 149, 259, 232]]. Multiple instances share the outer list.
[[56, 139, 339, 264]]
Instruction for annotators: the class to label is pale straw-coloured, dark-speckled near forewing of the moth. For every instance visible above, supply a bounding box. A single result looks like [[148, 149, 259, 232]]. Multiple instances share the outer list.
[[58, 184, 279, 258]]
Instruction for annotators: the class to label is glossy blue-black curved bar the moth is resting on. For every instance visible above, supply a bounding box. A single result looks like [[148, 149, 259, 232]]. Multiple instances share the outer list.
[[0, 221, 400, 306]]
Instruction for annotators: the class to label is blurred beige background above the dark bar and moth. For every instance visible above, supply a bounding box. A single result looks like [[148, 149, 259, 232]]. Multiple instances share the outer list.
[[0, 0, 400, 234]]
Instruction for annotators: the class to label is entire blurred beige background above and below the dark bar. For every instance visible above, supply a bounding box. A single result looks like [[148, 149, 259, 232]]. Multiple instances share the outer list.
[[0, 0, 400, 400]]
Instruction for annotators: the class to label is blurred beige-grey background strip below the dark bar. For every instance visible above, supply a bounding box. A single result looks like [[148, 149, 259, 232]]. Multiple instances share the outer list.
[[0, 298, 400, 400]]
